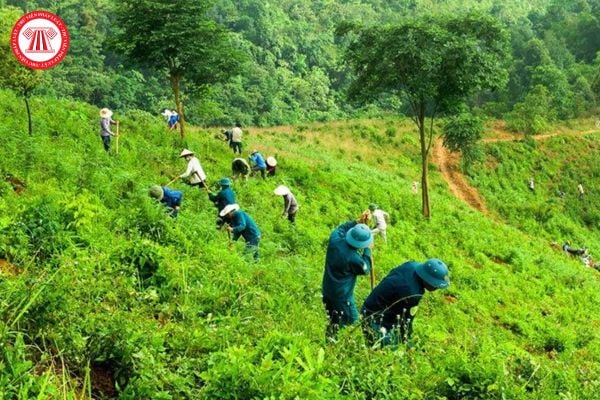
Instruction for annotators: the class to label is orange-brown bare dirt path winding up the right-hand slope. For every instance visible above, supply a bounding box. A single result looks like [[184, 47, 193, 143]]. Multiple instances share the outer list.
[[432, 124, 598, 217]]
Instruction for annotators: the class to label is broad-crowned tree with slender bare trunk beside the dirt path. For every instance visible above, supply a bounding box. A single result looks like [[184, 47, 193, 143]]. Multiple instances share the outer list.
[[346, 14, 508, 218]]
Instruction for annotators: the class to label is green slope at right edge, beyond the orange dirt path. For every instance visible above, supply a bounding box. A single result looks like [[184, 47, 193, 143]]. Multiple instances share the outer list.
[[469, 126, 600, 241]]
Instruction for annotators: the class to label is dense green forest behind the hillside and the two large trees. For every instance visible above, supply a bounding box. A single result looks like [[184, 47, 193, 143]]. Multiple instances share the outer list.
[[0, 0, 600, 126]]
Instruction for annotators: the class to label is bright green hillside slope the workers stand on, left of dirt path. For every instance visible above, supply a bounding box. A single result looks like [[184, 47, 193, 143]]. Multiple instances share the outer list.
[[0, 92, 600, 399]]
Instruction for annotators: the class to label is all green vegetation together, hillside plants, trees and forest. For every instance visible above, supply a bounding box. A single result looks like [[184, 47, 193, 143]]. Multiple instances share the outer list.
[[0, 0, 600, 400]]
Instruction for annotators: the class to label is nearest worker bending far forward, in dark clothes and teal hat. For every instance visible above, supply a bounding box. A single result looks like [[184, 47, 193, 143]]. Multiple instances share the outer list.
[[361, 258, 450, 347]]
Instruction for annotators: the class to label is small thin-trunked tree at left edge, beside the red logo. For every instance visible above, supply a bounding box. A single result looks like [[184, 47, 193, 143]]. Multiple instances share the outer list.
[[0, 7, 44, 136]]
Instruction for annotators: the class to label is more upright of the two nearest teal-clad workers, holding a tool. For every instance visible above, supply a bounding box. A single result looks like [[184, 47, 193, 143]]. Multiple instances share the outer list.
[[322, 221, 373, 341]]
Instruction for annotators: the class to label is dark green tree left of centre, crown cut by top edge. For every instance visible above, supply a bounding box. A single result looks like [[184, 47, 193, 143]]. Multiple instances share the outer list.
[[115, 0, 241, 137]]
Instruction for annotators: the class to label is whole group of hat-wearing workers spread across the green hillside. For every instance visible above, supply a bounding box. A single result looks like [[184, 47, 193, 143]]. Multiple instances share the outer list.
[[101, 110, 450, 347]]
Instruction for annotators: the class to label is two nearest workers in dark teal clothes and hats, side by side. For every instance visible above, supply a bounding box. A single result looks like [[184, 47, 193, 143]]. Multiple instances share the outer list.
[[322, 219, 450, 347]]
